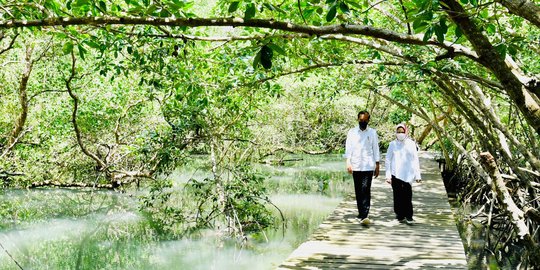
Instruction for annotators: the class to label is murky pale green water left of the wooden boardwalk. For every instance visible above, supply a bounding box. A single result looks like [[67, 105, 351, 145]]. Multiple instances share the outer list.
[[0, 155, 352, 270]]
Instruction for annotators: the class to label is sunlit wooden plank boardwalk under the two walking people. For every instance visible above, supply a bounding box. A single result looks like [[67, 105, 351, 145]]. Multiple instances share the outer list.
[[278, 154, 467, 269]]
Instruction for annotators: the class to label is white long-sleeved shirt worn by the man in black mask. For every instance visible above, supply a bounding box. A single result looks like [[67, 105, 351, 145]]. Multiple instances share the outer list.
[[344, 127, 380, 171]]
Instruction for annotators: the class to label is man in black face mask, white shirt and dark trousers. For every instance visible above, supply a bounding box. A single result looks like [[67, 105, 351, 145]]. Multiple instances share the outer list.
[[345, 111, 380, 225]]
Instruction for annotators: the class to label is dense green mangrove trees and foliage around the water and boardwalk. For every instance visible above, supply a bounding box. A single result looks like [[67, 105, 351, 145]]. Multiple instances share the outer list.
[[0, 0, 540, 267]]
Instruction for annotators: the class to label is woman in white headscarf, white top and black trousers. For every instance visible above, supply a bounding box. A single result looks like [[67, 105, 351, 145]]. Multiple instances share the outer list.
[[385, 124, 422, 225]]
